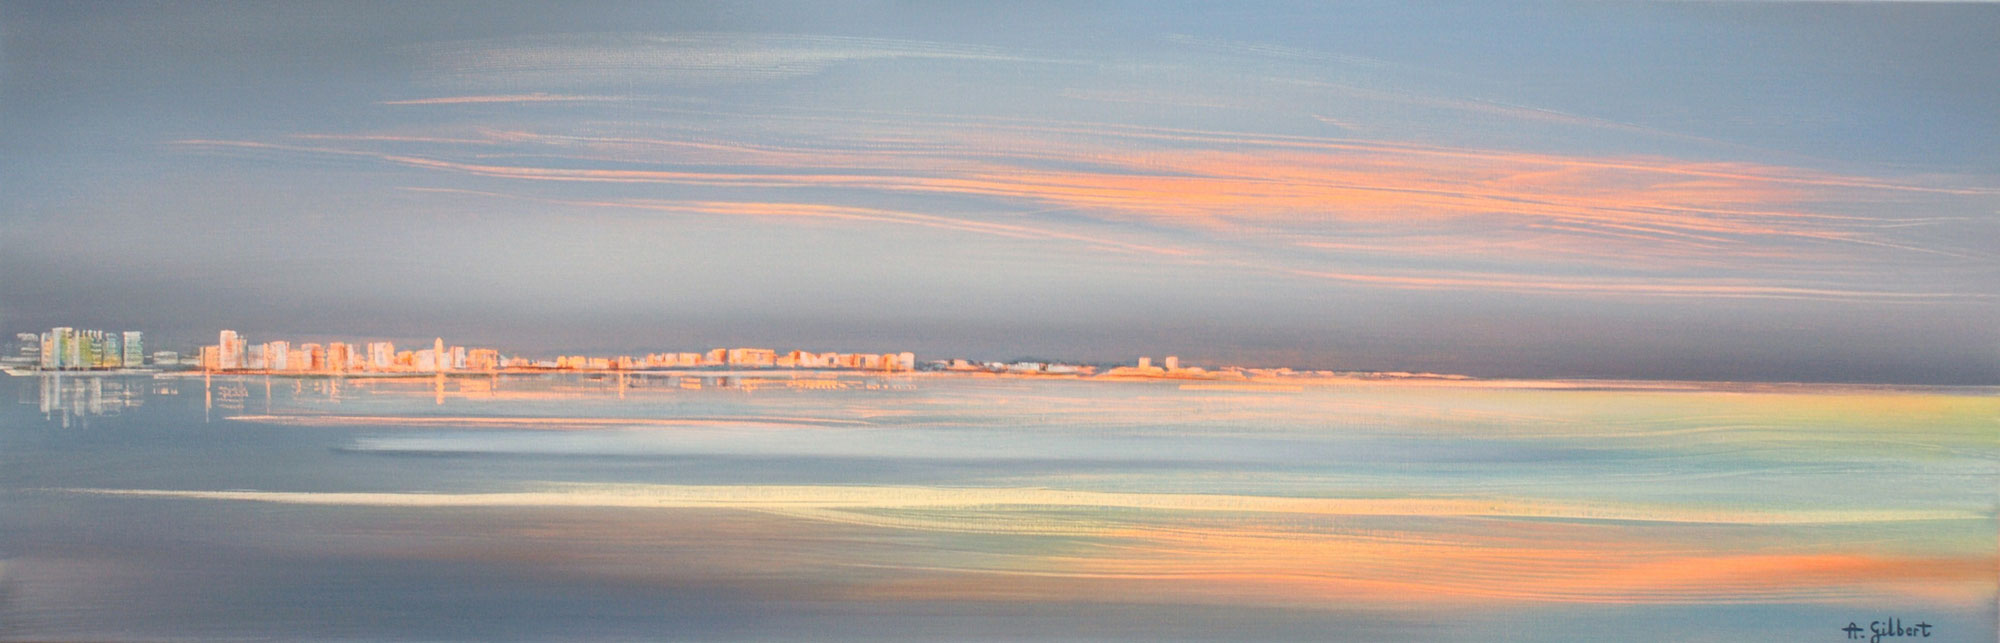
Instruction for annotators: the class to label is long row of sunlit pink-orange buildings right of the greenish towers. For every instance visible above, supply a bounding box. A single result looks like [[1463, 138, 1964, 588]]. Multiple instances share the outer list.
[[200, 329, 916, 373]]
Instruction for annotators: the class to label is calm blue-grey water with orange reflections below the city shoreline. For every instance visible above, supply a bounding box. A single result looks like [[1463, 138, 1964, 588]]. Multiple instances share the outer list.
[[0, 375, 2000, 641]]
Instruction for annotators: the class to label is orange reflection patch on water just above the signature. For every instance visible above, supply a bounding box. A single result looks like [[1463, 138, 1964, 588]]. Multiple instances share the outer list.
[[852, 523, 1996, 607]]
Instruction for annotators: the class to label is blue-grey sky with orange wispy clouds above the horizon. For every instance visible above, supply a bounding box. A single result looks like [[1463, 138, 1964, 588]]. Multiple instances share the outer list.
[[0, 2, 2000, 383]]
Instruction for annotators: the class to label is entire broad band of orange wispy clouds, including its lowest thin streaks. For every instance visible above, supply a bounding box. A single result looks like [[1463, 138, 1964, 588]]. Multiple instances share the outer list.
[[176, 101, 1994, 302]]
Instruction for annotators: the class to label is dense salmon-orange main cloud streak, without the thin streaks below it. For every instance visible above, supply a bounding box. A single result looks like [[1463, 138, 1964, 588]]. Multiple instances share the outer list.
[[223, 134, 1984, 252]]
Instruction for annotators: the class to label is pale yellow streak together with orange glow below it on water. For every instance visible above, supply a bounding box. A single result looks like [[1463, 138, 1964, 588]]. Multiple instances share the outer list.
[[72, 485, 1996, 607]]
